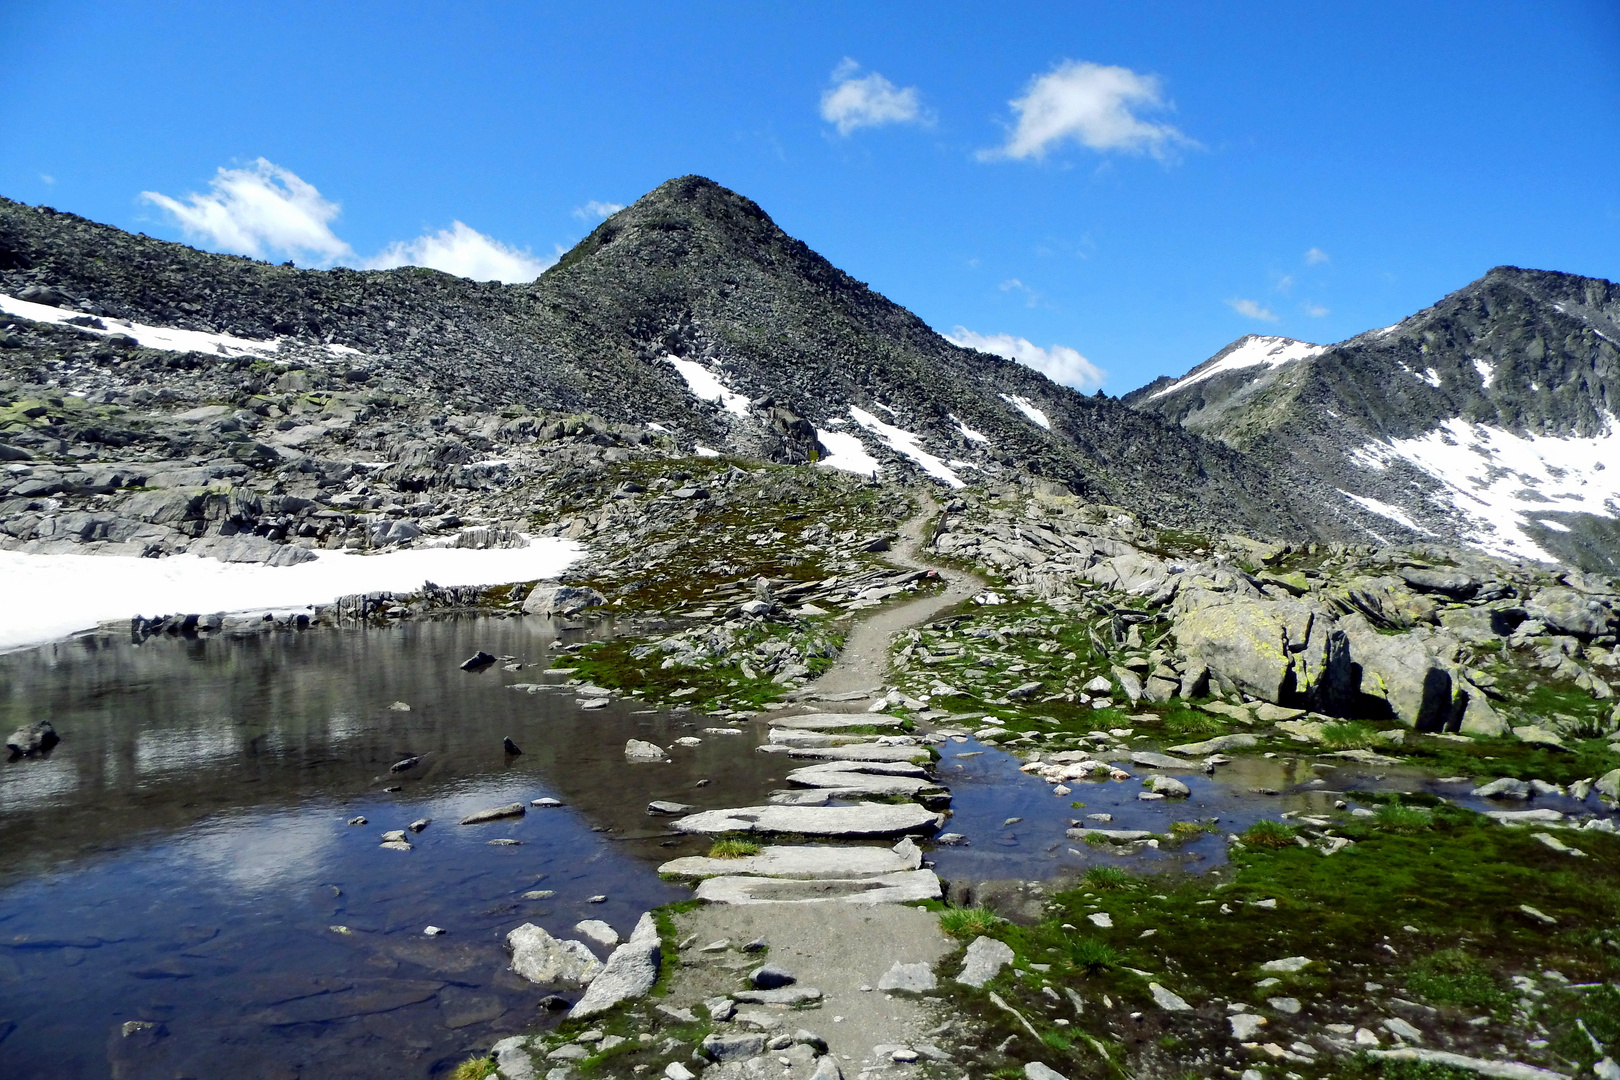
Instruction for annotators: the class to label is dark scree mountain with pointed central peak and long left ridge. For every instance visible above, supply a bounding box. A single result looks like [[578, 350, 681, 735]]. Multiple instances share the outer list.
[[0, 176, 1340, 538]]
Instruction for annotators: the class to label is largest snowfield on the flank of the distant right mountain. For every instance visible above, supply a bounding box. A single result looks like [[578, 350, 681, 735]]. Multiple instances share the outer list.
[[1351, 416, 1620, 562]]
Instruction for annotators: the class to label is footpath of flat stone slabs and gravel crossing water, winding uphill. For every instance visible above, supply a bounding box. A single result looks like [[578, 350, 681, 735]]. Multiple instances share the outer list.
[[644, 495, 985, 1080]]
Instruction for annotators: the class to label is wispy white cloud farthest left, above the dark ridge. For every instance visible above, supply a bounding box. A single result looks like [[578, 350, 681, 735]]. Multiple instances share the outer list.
[[141, 157, 353, 262]]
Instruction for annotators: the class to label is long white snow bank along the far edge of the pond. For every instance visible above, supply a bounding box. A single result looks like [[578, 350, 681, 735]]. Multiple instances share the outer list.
[[0, 536, 585, 649]]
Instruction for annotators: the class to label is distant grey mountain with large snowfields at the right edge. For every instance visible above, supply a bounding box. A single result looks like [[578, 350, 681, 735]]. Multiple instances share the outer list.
[[1124, 267, 1620, 573]]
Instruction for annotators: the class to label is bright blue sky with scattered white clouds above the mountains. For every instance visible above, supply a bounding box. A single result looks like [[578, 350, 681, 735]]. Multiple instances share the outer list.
[[0, 0, 1620, 393]]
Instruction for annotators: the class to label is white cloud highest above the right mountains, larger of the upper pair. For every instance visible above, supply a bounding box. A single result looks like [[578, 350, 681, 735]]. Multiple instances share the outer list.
[[978, 60, 1197, 160]]
